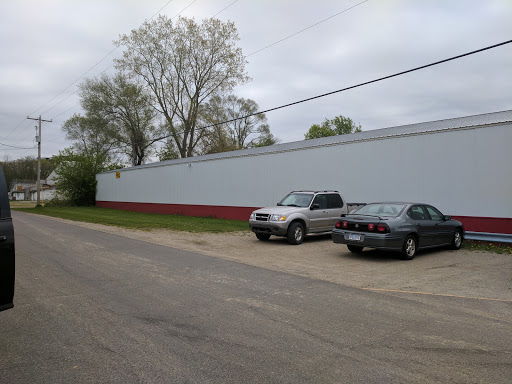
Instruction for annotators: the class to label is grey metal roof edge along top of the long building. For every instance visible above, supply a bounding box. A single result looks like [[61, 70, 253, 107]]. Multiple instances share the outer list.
[[100, 110, 512, 173]]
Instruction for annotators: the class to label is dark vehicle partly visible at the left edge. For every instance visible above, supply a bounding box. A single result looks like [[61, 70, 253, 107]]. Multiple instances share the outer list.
[[0, 167, 14, 311]]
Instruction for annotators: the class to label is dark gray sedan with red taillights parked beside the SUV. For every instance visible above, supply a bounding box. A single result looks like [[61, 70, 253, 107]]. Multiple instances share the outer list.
[[332, 203, 464, 260]]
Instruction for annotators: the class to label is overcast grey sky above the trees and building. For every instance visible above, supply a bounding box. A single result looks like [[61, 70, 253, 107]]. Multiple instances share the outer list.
[[0, 0, 512, 160]]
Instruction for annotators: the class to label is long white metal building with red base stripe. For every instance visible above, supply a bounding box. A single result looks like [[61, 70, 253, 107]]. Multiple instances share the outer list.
[[96, 110, 512, 240]]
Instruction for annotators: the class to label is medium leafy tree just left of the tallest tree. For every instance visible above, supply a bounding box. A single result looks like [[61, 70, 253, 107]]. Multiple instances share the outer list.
[[79, 73, 167, 165]]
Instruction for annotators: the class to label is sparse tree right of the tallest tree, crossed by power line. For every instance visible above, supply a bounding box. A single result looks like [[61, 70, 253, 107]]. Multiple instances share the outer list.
[[201, 95, 278, 153]]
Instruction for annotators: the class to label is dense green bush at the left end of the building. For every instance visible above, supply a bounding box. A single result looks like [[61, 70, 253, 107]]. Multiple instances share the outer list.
[[55, 148, 121, 206]]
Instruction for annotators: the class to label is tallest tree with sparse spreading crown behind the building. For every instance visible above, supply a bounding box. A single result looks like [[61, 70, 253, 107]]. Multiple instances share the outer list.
[[115, 16, 249, 157]]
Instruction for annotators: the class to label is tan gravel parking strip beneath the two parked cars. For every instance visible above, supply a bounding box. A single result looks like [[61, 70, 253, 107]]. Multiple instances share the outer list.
[[55, 219, 512, 301]]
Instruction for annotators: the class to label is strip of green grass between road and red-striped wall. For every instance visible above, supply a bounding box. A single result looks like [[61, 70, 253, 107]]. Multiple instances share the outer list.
[[12, 207, 249, 233]]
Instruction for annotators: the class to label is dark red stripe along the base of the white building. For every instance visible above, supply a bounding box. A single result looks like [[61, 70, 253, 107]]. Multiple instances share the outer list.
[[96, 201, 512, 235]]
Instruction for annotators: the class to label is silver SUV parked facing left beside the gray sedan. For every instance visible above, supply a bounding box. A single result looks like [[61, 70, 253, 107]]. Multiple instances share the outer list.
[[249, 191, 351, 244]]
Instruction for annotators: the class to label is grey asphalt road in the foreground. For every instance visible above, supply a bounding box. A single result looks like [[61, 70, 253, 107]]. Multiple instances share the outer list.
[[0, 212, 512, 383]]
